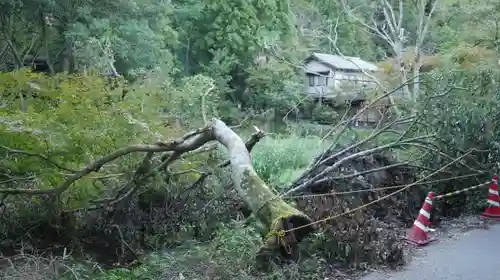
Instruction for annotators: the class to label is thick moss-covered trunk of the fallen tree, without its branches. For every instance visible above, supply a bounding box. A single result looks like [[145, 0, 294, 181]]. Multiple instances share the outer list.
[[212, 119, 313, 260]]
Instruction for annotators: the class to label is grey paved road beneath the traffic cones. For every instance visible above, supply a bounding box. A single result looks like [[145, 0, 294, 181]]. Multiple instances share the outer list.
[[361, 224, 500, 280]]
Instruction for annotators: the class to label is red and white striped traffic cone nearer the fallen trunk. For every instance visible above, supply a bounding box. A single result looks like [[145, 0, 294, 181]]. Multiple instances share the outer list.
[[405, 192, 437, 246]]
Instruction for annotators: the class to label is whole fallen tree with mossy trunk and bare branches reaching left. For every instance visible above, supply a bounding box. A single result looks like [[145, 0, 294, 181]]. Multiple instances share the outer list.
[[0, 119, 313, 260]]
